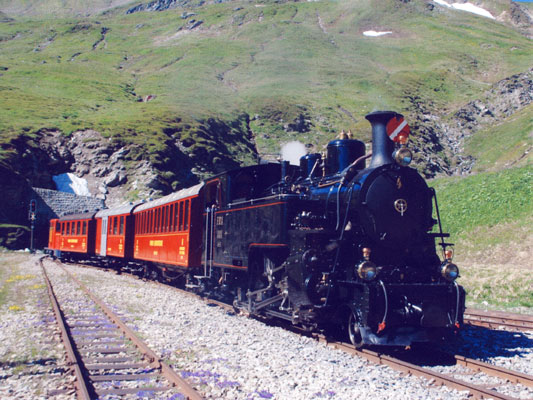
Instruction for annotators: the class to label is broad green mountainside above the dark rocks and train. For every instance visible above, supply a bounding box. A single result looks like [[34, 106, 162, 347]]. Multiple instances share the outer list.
[[0, 0, 533, 152]]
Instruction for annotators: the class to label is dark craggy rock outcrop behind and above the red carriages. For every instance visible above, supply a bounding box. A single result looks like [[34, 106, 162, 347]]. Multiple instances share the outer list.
[[12, 111, 257, 207]]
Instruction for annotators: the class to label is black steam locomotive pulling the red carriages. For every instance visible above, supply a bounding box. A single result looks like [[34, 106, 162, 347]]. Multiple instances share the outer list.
[[195, 112, 465, 347]]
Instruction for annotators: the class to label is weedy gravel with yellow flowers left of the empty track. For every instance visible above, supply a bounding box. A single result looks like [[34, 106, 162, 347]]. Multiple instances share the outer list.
[[0, 253, 76, 400]]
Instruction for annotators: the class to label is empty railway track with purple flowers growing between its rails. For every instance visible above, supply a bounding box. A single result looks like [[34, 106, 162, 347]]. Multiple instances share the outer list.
[[39, 259, 202, 400]]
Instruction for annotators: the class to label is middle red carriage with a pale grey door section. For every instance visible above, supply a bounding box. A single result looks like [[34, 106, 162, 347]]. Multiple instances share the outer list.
[[95, 204, 137, 259]]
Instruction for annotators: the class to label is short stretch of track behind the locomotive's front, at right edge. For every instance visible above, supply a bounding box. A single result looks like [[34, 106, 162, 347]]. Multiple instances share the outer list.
[[464, 308, 533, 332]]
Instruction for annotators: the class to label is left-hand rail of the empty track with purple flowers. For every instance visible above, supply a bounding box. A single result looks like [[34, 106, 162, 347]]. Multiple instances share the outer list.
[[39, 257, 92, 400]]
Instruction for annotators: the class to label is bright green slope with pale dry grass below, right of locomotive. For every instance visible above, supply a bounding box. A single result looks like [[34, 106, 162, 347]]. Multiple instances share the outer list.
[[433, 163, 533, 311]]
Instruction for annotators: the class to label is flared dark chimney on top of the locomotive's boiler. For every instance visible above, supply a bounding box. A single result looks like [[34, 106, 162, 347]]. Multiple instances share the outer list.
[[365, 111, 401, 168]]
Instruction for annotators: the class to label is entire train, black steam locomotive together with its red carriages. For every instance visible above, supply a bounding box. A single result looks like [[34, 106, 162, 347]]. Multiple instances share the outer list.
[[48, 111, 465, 347]]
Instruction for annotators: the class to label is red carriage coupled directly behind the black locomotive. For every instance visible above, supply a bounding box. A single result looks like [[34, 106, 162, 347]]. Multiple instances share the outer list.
[[133, 183, 204, 268]]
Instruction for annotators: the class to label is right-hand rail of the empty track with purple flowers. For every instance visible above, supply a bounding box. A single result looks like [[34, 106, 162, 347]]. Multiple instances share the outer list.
[[51, 264, 203, 400]]
